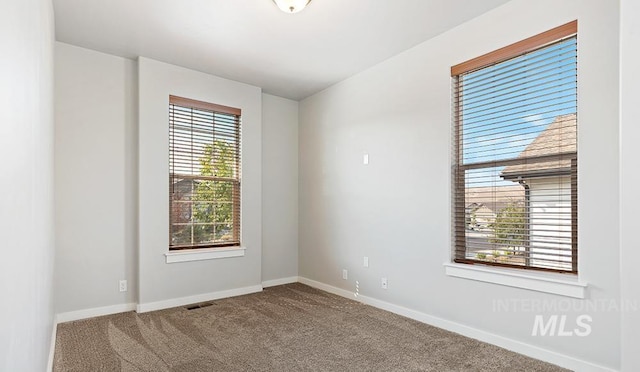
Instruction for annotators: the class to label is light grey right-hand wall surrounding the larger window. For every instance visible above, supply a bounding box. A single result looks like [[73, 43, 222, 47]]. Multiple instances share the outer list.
[[299, 0, 620, 368]]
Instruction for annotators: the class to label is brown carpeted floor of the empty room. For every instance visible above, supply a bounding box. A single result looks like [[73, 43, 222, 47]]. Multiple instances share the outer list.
[[54, 283, 562, 372]]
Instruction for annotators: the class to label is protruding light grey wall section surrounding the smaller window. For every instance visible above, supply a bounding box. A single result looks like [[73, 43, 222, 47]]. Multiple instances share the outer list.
[[138, 57, 262, 308]]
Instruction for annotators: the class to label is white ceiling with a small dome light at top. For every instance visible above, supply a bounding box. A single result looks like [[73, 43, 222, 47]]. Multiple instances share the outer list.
[[54, 0, 508, 100]]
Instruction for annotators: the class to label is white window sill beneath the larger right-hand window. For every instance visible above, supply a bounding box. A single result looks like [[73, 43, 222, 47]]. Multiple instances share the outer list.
[[444, 263, 587, 298]]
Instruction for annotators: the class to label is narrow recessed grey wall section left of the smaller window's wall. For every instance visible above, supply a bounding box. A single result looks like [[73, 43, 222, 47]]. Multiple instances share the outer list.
[[55, 43, 137, 313]]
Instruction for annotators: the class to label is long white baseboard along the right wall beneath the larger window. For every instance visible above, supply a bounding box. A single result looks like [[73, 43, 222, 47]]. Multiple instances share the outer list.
[[299, 277, 615, 372]]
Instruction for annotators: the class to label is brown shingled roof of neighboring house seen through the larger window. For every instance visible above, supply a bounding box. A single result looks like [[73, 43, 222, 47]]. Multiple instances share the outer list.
[[501, 114, 577, 180]]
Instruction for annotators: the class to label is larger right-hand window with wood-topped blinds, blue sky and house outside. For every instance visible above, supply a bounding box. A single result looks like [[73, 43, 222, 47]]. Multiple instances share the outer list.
[[451, 21, 578, 273]]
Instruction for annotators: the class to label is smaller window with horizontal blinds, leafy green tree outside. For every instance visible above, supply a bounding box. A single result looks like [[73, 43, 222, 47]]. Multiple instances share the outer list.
[[169, 96, 240, 249]]
